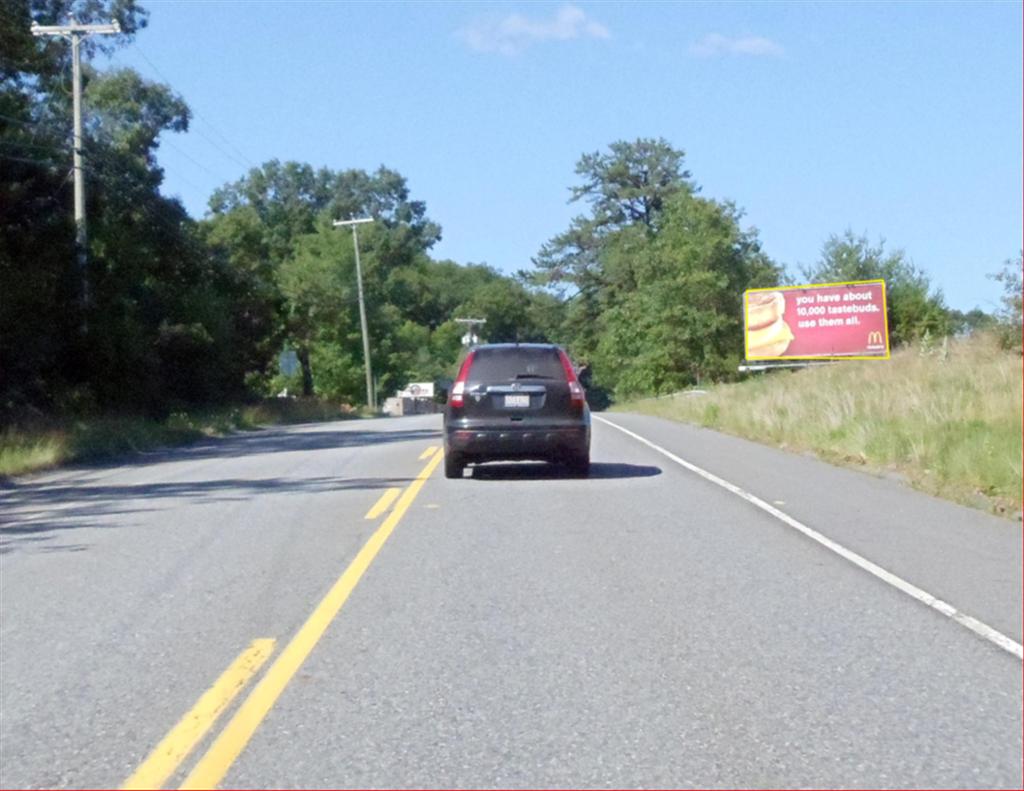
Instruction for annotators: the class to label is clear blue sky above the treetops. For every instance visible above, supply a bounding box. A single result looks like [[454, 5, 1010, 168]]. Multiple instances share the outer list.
[[99, 0, 1024, 309]]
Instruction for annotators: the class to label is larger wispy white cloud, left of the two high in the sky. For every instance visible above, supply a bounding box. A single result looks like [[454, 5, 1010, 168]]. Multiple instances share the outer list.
[[458, 5, 611, 55]]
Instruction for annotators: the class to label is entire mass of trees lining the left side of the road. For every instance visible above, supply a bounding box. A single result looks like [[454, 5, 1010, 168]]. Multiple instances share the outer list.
[[0, 0, 553, 416]]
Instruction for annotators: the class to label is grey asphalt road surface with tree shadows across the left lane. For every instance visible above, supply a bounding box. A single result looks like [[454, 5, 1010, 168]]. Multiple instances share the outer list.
[[0, 414, 1024, 788]]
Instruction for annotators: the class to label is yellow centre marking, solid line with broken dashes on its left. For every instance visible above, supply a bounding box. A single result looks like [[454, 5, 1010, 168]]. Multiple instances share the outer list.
[[123, 449, 444, 789]]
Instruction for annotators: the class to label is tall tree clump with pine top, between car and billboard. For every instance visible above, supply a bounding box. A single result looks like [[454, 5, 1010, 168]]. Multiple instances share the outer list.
[[532, 139, 781, 394]]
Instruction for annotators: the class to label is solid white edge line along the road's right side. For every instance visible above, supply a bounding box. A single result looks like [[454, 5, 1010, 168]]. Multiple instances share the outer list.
[[593, 415, 1024, 660]]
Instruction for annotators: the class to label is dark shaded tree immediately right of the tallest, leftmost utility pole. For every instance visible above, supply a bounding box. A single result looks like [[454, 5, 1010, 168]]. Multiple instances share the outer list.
[[80, 70, 270, 414]]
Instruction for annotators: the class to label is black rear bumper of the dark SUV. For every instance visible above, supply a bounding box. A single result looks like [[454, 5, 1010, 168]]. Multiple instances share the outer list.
[[444, 424, 590, 461]]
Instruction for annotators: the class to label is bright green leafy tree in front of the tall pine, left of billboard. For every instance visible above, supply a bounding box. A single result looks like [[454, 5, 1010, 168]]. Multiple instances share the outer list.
[[594, 192, 780, 394]]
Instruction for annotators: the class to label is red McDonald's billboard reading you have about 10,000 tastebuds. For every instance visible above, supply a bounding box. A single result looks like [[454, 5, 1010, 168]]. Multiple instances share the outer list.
[[743, 280, 889, 360]]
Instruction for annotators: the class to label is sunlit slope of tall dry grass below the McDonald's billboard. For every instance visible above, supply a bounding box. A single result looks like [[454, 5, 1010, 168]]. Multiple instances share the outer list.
[[615, 336, 1022, 516]]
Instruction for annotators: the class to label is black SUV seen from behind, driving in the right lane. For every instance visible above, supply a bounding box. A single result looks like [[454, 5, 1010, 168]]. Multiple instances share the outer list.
[[444, 343, 590, 477]]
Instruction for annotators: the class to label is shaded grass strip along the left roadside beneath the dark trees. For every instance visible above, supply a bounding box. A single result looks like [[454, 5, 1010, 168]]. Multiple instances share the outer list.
[[0, 399, 358, 475]]
